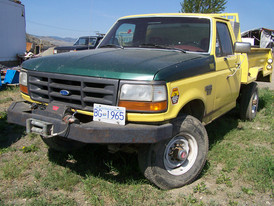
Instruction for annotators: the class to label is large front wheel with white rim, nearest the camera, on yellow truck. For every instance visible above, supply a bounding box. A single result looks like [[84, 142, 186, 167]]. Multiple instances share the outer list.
[[139, 116, 208, 189]]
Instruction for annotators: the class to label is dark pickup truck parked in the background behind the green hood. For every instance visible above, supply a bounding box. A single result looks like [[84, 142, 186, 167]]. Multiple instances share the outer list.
[[53, 35, 103, 54]]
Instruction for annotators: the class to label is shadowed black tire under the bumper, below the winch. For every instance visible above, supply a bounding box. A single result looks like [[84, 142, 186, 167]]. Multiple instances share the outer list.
[[41, 136, 85, 152]]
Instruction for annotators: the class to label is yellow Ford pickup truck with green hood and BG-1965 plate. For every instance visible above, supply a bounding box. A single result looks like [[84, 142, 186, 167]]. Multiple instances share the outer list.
[[8, 13, 273, 189]]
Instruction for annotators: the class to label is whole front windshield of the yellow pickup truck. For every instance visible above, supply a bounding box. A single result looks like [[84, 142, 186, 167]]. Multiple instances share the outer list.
[[100, 17, 210, 52]]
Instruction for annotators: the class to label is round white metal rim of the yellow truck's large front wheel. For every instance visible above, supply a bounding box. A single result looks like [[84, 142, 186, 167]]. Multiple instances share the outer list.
[[164, 134, 198, 175]]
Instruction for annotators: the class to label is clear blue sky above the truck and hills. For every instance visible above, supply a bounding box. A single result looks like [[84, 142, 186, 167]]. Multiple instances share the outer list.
[[21, 0, 274, 38]]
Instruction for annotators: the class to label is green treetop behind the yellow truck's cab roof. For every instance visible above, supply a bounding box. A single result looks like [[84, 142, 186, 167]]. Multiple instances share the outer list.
[[180, 0, 227, 13]]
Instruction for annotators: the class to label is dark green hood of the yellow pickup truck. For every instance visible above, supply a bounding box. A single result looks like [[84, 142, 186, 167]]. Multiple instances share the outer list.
[[22, 48, 212, 81]]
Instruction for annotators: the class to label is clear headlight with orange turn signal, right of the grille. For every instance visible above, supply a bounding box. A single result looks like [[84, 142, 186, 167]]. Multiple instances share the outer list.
[[119, 84, 167, 112]]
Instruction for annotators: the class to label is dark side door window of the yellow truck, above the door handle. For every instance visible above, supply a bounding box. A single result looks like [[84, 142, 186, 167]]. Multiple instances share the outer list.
[[216, 22, 233, 57]]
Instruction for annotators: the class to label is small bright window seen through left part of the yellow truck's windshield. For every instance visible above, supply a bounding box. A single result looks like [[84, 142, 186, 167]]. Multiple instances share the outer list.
[[115, 23, 135, 46]]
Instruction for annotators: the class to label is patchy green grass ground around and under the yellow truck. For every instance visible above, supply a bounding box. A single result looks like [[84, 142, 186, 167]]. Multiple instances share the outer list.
[[0, 88, 274, 206]]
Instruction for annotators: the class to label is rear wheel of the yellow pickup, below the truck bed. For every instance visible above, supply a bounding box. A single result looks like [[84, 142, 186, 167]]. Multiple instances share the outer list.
[[240, 82, 259, 120]]
